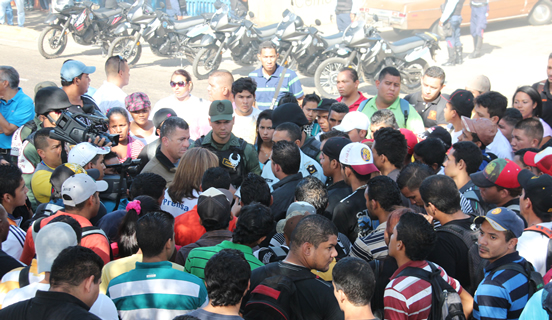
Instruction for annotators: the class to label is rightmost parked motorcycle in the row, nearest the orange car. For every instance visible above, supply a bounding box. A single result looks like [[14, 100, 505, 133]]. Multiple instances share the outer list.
[[314, 17, 439, 98]]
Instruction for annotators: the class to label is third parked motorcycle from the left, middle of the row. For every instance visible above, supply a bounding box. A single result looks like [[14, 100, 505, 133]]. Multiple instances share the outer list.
[[192, 4, 278, 79]]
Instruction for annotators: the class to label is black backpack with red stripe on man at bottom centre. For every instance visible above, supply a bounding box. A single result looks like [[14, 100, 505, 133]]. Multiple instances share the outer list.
[[243, 263, 316, 320]]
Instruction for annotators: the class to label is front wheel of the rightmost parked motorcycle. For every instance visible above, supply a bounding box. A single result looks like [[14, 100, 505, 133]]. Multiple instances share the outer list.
[[314, 58, 347, 99]]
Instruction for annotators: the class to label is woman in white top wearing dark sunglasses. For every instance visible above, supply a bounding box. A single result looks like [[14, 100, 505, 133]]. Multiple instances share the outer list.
[[149, 69, 211, 140]]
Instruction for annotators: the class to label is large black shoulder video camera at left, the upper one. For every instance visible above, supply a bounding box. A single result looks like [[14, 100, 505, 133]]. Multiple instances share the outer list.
[[50, 110, 119, 147]]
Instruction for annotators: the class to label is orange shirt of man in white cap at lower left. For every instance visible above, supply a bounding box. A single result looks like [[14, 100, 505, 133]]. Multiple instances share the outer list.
[[19, 211, 110, 264]]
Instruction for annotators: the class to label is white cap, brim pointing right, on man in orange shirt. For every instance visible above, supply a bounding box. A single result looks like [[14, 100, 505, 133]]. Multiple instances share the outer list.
[[61, 173, 108, 207]]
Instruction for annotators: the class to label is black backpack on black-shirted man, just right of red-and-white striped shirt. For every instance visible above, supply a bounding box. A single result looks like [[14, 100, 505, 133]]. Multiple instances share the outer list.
[[436, 223, 489, 296]]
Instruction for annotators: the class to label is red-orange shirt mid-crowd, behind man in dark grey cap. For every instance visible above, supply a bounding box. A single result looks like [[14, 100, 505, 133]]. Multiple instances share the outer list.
[[174, 205, 238, 246]]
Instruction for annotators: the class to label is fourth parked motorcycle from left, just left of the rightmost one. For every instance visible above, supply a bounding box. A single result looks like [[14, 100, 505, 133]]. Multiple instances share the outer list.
[[272, 9, 343, 77]]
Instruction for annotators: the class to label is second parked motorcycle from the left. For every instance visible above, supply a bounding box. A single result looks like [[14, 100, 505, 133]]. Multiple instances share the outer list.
[[109, 0, 211, 65]]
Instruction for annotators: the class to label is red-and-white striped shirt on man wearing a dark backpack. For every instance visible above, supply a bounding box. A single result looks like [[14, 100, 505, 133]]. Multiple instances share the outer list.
[[383, 260, 463, 320]]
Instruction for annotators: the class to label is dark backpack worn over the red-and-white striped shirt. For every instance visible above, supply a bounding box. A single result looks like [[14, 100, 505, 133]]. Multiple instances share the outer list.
[[397, 261, 466, 320]]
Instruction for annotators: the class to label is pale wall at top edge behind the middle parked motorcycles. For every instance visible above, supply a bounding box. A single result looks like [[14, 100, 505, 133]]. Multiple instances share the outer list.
[[249, 0, 336, 26]]
